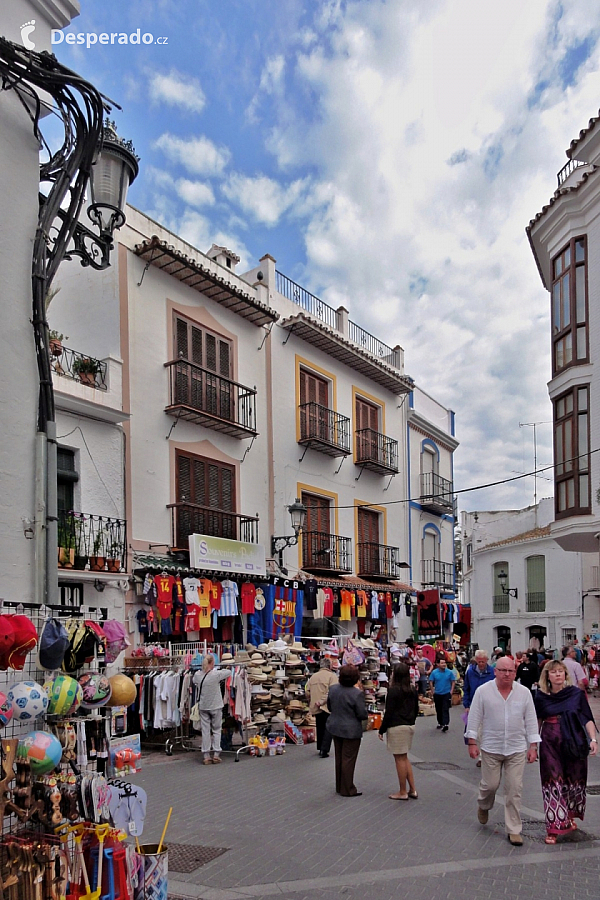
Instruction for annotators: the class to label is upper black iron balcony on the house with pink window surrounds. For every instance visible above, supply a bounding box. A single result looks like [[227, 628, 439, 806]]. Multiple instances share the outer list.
[[165, 359, 257, 438]]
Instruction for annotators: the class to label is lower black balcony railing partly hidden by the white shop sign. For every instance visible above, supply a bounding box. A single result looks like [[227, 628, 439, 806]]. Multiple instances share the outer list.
[[168, 502, 258, 551]]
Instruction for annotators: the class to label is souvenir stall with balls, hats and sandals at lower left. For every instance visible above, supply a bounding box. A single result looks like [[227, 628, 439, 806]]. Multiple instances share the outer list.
[[0, 603, 166, 900]]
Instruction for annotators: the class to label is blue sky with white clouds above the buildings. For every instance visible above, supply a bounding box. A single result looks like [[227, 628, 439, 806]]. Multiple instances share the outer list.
[[48, 0, 600, 509]]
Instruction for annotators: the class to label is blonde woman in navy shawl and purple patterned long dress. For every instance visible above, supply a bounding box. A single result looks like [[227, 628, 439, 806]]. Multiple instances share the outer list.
[[534, 660, 598, 844]]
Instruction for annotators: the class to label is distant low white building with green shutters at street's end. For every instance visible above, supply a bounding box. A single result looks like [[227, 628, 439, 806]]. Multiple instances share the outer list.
[[460, 498, 599, 652]]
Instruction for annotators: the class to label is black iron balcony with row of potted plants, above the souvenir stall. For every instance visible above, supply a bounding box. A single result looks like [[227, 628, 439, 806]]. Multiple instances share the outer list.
[[58, 511, 127, 572]]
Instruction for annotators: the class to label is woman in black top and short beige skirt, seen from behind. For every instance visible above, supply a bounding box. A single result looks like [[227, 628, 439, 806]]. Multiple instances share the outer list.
[[379, 663, 419, 800]]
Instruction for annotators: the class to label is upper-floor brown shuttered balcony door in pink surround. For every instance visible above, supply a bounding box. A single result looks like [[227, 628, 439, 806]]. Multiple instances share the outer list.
[[175, 316, 235, 419]]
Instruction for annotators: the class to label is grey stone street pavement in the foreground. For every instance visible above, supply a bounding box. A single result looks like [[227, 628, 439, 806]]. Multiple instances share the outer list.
[[132, 702, 600, 900]]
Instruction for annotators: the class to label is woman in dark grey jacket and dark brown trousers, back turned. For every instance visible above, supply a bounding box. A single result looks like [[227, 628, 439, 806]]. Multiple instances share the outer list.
[[326, 665, 369, 797]]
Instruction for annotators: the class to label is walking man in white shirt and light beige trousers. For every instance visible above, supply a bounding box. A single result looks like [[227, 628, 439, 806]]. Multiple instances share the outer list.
[[466, 656, 541, 847]]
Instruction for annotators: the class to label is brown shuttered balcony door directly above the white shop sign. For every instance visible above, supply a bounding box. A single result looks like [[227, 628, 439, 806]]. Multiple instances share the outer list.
[[175, 451, 237, 549]]
